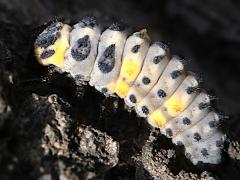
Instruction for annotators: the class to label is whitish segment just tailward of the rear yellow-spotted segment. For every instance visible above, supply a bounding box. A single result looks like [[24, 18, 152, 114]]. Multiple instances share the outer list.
[[161, 93, 210, 138]]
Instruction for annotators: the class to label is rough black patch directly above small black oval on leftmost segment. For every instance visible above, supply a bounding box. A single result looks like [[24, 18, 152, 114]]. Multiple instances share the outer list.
[[35, 32, 60, 49]]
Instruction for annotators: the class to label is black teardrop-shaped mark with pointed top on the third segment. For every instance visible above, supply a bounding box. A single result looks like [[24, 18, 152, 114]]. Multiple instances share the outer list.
[[98, 44, 115, 74]]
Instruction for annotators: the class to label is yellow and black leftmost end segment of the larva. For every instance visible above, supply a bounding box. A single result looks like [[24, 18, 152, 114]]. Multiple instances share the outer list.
[[34, 22, 71, 68]]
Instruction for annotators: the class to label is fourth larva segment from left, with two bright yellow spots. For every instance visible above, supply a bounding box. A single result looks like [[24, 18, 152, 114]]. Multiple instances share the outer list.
[[114, 29, 150, 97]]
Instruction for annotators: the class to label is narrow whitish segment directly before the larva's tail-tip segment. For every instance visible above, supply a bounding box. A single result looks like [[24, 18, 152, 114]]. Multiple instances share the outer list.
[[172, 111, 219, 146]]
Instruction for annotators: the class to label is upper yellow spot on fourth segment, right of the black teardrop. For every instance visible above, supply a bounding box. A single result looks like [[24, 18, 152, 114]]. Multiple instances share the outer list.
[[121, 59, 141, 82]]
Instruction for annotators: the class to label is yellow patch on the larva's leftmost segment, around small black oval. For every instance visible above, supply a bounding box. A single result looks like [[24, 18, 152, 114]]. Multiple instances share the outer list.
[[35, 37, 69, 69]]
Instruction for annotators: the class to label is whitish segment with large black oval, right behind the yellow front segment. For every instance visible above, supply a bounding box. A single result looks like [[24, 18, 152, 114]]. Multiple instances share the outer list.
[[64, 17, 101, 81]]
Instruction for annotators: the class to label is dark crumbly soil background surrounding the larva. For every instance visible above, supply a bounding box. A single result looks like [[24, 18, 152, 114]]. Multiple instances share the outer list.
[[0, 0, 240, 180]]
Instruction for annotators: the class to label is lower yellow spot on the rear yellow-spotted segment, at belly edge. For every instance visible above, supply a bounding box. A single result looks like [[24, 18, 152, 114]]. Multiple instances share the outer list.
[[148, 109, 167, 127]]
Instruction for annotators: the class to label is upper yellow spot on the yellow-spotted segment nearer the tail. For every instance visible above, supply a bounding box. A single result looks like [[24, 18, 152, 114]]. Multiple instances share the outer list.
[[164, 95, 186, 117]]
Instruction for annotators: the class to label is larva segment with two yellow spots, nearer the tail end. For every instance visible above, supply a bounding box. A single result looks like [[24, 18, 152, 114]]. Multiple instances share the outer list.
[[148, 75, 198, 128]]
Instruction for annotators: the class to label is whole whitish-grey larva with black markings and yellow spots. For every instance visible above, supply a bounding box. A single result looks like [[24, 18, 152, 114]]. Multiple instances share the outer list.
[[34, 17, 224, 164]]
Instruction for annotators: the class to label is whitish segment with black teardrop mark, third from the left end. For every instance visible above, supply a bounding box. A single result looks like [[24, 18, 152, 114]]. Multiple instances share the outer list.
[[89, 24, 127, 94]]
